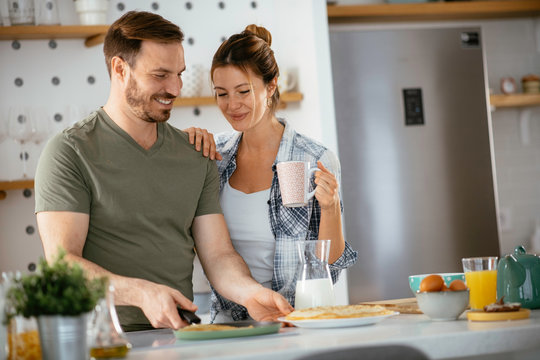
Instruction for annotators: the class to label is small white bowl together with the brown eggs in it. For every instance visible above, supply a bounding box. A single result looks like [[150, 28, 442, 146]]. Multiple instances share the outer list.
[[415, 274, 469, 321]]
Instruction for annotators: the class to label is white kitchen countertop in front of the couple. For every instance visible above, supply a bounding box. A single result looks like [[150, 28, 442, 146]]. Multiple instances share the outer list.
[[124, 309, 540, 360]]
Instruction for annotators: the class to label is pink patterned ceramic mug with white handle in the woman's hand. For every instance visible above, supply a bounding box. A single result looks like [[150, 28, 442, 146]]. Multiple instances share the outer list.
[[276, 161, 321, 207]]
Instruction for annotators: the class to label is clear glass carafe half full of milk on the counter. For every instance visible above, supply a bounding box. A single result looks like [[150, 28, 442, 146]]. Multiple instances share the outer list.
[[294, 240, 335, 310]]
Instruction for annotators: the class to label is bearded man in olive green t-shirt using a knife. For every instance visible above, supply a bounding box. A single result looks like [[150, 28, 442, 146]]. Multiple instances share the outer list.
[[35, 11, 292, 331]]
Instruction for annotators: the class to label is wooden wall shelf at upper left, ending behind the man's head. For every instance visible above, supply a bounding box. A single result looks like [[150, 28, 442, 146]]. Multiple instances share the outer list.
[[0, 25, 109, 47]]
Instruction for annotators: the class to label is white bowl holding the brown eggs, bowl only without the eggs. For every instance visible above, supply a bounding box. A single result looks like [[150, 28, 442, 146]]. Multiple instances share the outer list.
[[416, 289, 469, 321]]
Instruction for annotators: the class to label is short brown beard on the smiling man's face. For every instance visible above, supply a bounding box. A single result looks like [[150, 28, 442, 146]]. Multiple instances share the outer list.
[[126, 77, 174, 122]]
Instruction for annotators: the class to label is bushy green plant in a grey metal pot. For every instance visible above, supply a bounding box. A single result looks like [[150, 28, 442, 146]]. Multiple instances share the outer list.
[[6, 250, 107, 360]]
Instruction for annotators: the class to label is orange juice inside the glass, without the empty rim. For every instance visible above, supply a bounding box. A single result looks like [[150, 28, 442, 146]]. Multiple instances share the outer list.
[[465, 270, 497, 310]]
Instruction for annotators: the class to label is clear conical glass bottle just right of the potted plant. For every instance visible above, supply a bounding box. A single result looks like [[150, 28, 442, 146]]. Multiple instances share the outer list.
[[89, 285, 131, 360]]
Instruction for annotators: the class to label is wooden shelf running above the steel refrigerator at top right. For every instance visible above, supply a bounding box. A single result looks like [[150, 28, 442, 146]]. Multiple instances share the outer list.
[[327, 0, 540, 23]]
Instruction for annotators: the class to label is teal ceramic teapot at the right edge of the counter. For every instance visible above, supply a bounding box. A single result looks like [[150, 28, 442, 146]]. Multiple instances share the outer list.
[[497, 246, 540, 309]]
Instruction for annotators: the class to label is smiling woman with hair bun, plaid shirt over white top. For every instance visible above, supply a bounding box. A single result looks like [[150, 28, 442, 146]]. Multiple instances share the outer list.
[[191, 25, 357, 322]]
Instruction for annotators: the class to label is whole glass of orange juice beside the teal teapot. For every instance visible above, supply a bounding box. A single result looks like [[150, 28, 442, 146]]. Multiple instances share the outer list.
[[461, 256, 498, 310]]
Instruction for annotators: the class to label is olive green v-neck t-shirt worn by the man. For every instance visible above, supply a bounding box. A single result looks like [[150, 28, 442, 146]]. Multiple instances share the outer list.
[[35, 109, 221, 331]]
